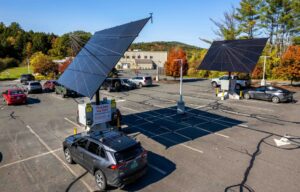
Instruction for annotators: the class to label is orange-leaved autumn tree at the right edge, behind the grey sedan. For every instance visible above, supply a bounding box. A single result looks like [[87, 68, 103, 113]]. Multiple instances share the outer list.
[[273, 45, 300, 85]]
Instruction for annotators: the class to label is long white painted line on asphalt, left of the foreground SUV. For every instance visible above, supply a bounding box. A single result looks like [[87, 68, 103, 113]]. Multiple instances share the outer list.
[[26, 125, 94, 191]]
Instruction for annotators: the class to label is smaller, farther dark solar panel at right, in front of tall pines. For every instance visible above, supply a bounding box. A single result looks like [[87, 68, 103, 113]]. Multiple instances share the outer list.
[[198, 38, 268, 73]]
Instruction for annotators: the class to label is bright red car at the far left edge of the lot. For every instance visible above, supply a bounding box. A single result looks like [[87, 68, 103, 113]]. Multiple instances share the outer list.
[[2, 88, 27, 105]]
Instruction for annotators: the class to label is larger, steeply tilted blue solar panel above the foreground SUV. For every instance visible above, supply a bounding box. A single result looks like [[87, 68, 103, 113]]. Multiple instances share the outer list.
[[58, 17, 151, 98]]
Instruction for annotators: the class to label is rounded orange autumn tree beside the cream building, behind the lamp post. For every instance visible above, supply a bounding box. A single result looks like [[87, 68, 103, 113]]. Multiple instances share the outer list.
[[165, 47, 188, 78]]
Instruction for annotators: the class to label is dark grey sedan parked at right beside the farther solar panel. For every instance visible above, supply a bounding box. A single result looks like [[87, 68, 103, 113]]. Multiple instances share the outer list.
[[244, 86, 293, 103]]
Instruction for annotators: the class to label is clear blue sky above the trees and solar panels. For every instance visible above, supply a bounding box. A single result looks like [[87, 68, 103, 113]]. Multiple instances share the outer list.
[[0, 0, 239, 47]]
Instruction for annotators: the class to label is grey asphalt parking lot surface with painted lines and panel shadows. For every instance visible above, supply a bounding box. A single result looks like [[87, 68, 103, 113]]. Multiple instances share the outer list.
[[0, 80, 300, 192]]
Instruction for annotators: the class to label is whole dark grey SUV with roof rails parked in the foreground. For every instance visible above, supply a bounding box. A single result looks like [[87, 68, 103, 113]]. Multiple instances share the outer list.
[[63, 130, 147, 190]]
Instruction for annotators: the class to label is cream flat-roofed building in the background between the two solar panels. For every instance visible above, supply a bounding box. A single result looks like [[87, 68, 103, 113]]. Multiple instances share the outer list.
[[116, 50, 168, 69]]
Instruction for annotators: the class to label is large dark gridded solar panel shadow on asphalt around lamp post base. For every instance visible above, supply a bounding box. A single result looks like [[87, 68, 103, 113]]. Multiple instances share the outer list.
[[124, 106, 244, 147]]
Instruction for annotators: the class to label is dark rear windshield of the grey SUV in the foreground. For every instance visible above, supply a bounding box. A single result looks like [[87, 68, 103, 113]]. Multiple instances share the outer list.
[[114, 143, 143, 163]]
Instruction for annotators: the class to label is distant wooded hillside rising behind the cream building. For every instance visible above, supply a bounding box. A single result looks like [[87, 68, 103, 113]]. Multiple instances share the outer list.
[[130, 41, 202, 52]]
